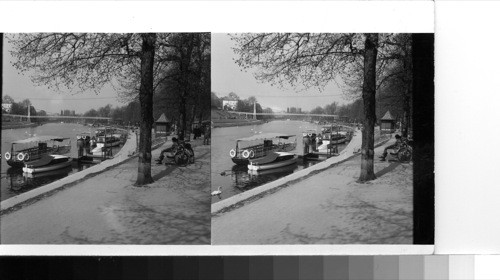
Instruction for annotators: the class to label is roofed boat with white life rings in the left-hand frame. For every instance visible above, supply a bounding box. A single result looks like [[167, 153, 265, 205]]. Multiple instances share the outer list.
[[5, 136, 71, 168]]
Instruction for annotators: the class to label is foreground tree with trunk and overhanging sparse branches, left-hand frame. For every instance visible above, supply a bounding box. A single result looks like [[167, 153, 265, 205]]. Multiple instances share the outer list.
[[10, 33, 164, 185]]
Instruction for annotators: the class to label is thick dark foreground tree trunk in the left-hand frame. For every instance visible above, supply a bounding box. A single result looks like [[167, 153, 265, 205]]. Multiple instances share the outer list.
[[135, 33, 156, 186]]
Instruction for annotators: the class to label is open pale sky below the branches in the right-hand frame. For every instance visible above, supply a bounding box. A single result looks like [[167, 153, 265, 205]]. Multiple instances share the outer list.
[[212, 33, 352, 111]]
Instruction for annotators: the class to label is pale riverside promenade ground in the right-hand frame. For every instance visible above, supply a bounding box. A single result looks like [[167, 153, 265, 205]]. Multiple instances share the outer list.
[[212, 139, 413, 244]]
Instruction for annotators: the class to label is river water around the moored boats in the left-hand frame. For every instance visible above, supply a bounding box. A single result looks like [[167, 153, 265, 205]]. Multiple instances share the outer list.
[[0, 123, 124, 200]]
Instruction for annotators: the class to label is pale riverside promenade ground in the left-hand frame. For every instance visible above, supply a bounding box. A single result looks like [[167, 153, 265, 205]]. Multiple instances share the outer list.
[[0, 140, 210, 244]]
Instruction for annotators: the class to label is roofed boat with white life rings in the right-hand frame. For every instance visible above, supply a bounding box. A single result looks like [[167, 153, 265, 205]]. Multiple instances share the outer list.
[[229, 133, 297, 165]]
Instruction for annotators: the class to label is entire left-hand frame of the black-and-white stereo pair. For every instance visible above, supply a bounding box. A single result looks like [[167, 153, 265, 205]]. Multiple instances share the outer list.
[[0, 33, 211, 245]]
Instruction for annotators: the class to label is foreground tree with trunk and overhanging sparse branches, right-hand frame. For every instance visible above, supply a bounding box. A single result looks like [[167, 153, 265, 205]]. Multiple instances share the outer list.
[[232, 33, 378, 182]]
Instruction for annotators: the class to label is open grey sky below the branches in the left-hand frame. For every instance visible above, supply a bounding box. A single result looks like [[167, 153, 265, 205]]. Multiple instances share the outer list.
[[2, 37, 124, 113]]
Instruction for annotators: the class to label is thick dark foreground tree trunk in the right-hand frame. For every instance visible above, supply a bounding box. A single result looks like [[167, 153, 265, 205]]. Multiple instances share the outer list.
[[358, 34, 378, 182]]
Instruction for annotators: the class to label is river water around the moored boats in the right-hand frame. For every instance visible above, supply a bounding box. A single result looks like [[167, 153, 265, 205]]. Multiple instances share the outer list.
[[211, 121, 345, 203]]
